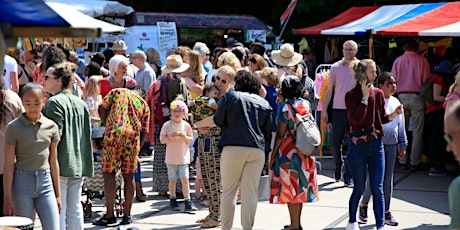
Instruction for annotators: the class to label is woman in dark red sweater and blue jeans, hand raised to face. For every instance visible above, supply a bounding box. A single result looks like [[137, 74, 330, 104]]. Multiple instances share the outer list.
[[345, 59, 403, 230]]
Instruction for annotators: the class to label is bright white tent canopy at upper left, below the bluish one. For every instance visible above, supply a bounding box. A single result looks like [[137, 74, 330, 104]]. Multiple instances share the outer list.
[[46, 2, 126, 33]]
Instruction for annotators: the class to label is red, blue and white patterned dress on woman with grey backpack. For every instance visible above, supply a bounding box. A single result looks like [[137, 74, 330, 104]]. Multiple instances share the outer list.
[[270, 99, 318, 204]]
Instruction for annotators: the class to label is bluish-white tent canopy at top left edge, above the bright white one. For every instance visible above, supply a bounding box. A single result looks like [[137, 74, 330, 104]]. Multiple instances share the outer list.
[[45, 0, 134, 18]]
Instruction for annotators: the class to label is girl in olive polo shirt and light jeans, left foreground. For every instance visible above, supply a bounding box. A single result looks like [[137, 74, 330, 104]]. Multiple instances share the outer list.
[[3, 83, 61, 229]]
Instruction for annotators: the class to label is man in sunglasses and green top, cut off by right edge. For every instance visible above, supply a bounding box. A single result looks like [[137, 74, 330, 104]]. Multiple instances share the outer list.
[[444, 100, 460, 230]]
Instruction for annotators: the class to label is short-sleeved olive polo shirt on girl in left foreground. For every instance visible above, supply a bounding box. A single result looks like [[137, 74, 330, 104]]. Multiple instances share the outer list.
[[5, 114, 59, 171]]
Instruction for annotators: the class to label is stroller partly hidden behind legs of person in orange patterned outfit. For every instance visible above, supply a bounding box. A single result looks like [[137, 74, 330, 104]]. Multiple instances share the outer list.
[[81, 161, 124, 218]]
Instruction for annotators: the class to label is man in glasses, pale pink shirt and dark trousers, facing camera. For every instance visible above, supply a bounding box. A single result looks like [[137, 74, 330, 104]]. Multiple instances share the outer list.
[[321, 40, 358, 187]]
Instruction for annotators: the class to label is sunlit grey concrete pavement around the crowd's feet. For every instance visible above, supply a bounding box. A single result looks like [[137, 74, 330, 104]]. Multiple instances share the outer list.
[[35, 157, 454, 230]]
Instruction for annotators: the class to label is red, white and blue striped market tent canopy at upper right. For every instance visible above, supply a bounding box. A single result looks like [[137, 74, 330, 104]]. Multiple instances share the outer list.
[[293, 2, 460, 36]]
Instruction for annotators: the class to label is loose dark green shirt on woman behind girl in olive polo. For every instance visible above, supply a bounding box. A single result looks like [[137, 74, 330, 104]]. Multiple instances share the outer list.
[[45, 91, 93, 178]]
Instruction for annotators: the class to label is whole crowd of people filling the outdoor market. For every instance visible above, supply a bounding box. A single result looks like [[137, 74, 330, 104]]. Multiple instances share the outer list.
[[0, 36, 460, 230]]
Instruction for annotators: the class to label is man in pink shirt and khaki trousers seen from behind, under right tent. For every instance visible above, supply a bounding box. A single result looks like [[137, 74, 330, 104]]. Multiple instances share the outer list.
[[391, 40, 430, 171]]
